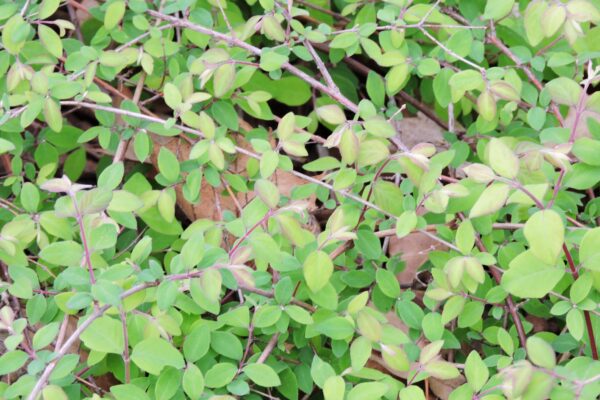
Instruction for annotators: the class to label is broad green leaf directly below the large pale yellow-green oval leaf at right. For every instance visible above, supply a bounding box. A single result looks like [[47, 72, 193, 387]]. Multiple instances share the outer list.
[[502, 250, 565, 299]]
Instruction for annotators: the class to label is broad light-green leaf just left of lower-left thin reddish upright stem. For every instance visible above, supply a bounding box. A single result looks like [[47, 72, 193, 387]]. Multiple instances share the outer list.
[[81, 316, 124, 354]]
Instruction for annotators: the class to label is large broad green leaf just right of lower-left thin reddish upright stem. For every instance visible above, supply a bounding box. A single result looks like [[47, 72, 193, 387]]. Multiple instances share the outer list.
[[131, 338, 184, 375]]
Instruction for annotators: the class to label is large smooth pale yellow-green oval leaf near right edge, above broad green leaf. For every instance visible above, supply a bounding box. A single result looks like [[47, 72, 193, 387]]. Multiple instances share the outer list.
[[523, 210, 565, 265]]
